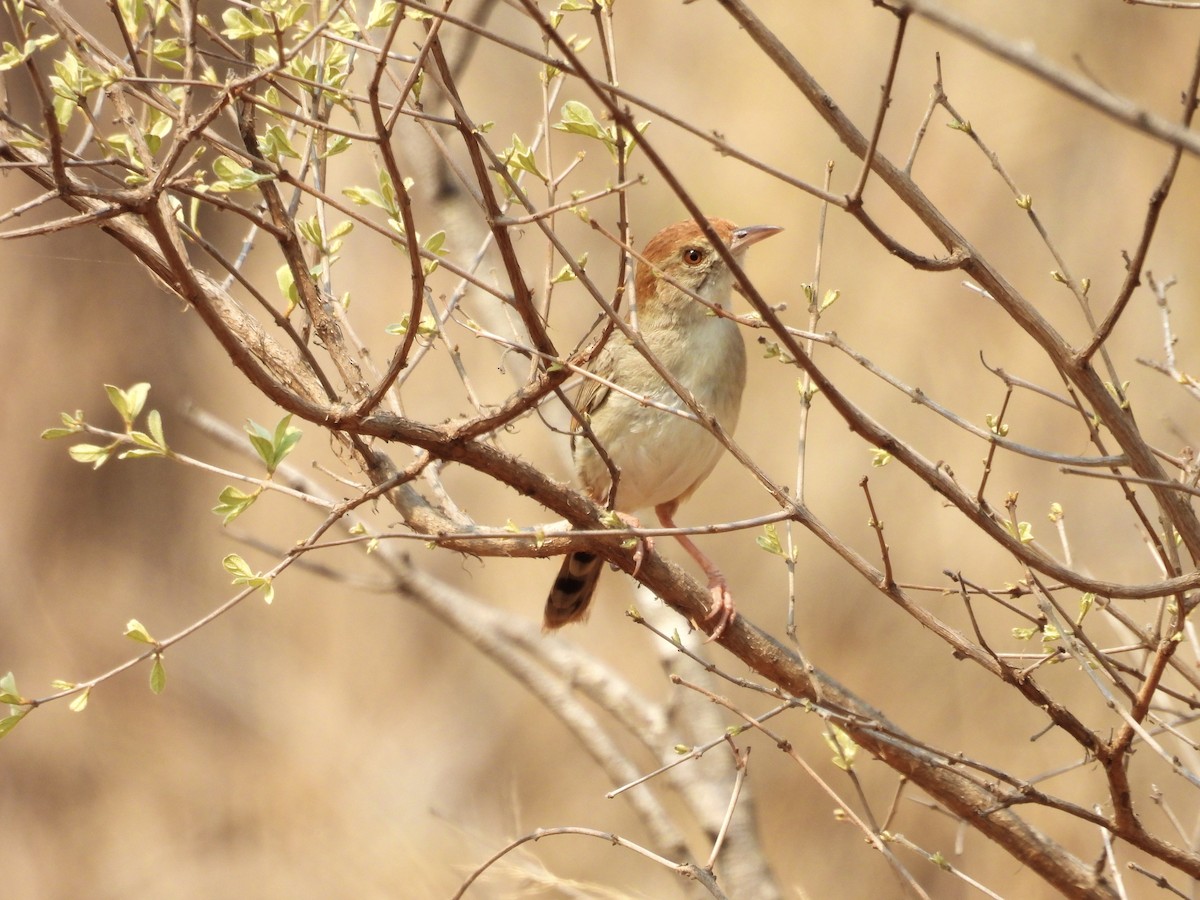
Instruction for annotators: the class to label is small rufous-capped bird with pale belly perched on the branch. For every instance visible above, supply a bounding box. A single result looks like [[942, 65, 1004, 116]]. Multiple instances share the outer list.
[[544, 218, 782, 637]]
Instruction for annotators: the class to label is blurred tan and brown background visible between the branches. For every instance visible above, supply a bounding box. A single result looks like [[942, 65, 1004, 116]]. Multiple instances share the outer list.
[[0, 0, 1200, 898]]
